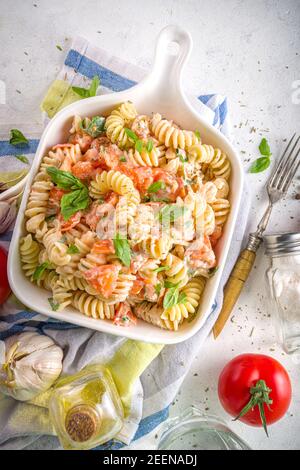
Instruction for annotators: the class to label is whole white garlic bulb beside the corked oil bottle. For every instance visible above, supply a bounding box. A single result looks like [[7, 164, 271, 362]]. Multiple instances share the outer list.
[[0, 332, 63, 401]]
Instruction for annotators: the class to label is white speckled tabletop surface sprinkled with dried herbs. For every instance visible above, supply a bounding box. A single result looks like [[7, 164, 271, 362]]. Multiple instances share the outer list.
[[0, 0, 300, 449]]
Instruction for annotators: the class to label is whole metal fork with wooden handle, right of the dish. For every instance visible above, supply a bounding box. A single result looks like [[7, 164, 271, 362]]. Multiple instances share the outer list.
[[213, 134, 300, 338]]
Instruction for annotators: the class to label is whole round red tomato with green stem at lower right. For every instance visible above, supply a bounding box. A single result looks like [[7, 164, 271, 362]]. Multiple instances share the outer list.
[[218, 354, 292, 432]]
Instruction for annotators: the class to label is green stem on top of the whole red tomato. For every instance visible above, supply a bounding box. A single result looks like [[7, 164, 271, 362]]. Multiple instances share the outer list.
[[233, 380, 273, 437]]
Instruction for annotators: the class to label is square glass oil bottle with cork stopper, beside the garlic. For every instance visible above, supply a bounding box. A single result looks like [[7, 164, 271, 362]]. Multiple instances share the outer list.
[[49, 365, 124, 450]]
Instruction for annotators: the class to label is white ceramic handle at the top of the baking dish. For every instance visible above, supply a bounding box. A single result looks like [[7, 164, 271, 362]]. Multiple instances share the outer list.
[[144, 25, 193, 101]]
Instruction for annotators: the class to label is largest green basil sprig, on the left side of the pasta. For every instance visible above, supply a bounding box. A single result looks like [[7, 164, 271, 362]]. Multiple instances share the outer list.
[[47, 167, 89, 220]]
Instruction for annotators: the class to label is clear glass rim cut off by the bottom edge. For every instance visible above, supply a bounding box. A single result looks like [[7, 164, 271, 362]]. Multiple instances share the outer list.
[[158, 405, 250, 450]]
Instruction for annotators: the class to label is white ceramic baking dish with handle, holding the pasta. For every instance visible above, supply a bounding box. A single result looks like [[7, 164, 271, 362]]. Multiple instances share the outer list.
[[8, 26, 243, 344]]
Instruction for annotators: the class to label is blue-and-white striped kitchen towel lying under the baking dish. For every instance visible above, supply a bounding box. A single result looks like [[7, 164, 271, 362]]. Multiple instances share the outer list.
[[0, 38, 249, 449]]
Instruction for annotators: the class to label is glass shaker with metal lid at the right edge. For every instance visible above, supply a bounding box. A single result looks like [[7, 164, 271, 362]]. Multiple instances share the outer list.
[[264, 233, 300, 354]]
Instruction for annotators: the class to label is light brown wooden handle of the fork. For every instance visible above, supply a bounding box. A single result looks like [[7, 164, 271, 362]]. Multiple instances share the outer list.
[[213, 250, 256, 339]]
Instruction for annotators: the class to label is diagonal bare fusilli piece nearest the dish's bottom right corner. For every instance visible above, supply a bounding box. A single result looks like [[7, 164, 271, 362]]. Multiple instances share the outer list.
[[161, 277, 205, 331]]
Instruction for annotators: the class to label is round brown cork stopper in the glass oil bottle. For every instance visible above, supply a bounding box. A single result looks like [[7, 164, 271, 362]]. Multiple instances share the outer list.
[[65, 405, 101, 442]]
